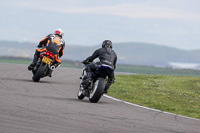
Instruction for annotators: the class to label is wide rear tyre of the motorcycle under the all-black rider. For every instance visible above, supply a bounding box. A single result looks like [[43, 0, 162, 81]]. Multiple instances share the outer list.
[[89, 78, 105, 103]]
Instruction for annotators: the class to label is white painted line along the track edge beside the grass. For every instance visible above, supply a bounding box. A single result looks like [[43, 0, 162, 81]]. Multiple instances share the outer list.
[[103, 94, 200, 121]]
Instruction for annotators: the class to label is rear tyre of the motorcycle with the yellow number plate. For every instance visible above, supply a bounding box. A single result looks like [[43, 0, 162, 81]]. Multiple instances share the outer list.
[[32, 62, 47, 82]]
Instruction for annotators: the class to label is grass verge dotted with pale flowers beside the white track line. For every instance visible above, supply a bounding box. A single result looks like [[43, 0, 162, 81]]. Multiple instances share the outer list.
[[108, 74, 200, 119]]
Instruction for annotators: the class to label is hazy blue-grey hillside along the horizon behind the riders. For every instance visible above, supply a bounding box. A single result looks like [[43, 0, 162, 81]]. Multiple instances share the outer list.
[[0, 41, 200, 66]]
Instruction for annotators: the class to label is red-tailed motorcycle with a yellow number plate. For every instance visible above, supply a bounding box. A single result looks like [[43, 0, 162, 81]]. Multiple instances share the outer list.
[[32, 51, 55, 82]]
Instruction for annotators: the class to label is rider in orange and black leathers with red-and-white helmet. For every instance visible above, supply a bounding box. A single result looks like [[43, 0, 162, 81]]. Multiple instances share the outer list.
[[28, 28, 65, 73]]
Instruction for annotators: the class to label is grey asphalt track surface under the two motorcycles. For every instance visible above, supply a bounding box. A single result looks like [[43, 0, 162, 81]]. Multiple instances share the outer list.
[[0, 63, 200, 133]]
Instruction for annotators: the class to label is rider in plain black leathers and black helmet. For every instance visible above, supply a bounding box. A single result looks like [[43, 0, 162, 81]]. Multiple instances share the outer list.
[[83, 40, 117, 93]]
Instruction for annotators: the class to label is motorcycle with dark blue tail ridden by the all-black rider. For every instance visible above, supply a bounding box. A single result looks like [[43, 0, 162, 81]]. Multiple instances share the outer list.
[[77, 64, 114, 103]]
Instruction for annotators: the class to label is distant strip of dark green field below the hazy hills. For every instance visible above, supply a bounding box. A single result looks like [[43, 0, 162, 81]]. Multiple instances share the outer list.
[[0, 57, 200, 77]]
